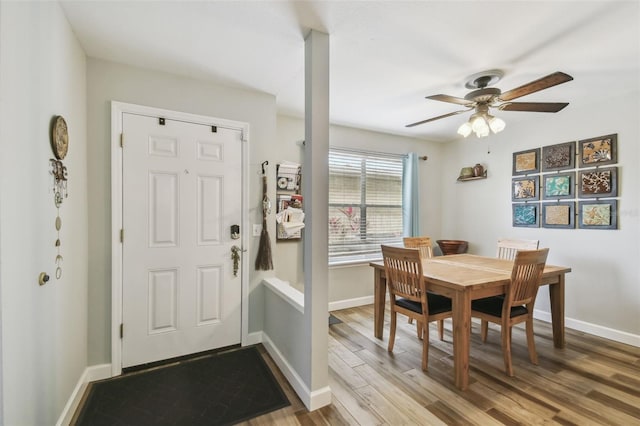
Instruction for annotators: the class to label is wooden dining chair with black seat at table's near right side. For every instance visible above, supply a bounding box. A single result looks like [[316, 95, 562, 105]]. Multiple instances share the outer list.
[[471, 248, 549, 377]]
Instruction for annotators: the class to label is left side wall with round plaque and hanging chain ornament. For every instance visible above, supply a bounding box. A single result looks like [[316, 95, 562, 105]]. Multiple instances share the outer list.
[[0, 2, 88, 425]]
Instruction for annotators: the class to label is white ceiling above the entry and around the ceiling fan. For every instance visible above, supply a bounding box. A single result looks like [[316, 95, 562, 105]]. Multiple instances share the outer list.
[[61, 0, 640, 141]]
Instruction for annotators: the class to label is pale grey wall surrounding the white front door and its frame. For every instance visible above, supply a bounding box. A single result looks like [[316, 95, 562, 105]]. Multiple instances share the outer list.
[[87, 58, 276, 365]]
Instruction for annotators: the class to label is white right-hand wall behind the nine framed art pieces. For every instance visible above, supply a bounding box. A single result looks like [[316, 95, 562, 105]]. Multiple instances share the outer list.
[[442, 90, 640, 345]]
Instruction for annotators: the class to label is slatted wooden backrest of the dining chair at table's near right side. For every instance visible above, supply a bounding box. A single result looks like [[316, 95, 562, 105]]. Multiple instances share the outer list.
[[505, 248, 549, 306]]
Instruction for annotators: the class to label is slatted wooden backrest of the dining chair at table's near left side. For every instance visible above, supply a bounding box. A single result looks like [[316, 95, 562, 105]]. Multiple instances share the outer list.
[[382, 245, 427, 309]]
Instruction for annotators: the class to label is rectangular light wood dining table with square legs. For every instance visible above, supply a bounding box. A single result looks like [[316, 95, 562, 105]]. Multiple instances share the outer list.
[[369, 254, 571, 390]]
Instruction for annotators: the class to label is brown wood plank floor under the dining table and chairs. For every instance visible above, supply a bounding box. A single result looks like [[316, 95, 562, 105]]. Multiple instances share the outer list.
[[243, 305, 640, 426]]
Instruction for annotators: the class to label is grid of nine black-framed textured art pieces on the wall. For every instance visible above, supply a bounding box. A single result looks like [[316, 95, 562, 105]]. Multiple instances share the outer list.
[[511, 134, 619, 229]]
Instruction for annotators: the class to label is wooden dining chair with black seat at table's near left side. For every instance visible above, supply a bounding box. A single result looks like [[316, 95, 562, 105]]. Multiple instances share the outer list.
[[382, 245, 452, 371]]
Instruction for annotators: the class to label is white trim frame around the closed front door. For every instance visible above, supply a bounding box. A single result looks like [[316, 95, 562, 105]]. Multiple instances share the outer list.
[[111, 101, 249, 376]]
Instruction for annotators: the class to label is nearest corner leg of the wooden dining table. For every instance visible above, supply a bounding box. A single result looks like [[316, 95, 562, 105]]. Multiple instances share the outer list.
[[452, 291, 471, 390]]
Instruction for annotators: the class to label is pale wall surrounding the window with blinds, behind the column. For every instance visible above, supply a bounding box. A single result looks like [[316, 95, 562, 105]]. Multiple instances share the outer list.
[[274, 116, 443, 303]]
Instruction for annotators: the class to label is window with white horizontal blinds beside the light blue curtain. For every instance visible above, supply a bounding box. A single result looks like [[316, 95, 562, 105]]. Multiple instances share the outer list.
[[329, 148, 403, 265]]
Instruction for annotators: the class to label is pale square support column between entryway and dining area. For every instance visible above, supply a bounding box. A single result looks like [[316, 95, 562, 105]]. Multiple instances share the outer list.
[[300, 30, 331, 410]]
